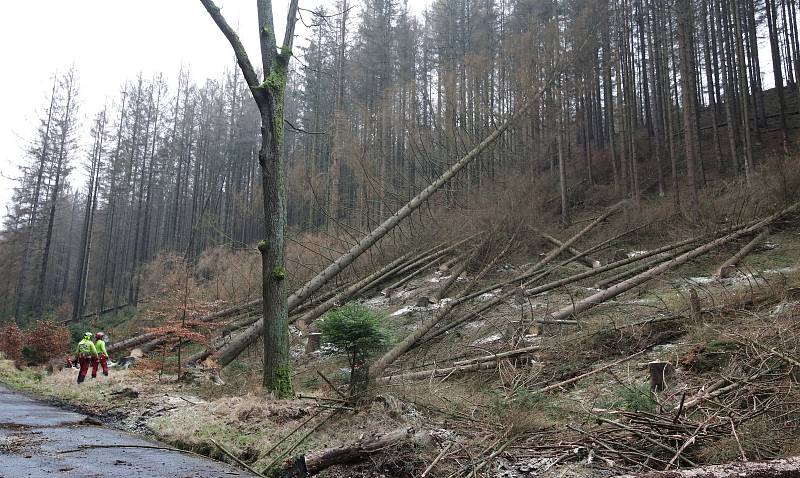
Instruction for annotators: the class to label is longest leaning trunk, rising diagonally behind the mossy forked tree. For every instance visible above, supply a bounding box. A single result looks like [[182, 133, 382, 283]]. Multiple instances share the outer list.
[[209, 75, 563, 367]]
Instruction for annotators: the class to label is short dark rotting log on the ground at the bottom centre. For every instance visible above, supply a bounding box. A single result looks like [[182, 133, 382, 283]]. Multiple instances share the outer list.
[[284, 428, 431, 478]]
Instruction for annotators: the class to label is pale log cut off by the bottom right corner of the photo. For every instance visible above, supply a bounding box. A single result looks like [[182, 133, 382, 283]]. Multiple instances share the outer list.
[[614, 457, 800, 478]]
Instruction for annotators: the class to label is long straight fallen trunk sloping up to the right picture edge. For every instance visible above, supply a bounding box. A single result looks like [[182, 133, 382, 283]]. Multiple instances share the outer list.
[[545, 202, 800, 320]]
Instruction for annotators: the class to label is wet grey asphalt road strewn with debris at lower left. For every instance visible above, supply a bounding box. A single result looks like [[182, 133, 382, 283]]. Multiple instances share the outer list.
[[0, 385, 254, 478]]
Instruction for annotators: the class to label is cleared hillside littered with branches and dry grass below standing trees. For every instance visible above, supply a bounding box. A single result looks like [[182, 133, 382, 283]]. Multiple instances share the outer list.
[[2, 162, 800, 477]]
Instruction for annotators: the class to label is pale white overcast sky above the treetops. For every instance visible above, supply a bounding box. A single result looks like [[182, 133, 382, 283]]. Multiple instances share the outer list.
[[0, 0, 428, 215]]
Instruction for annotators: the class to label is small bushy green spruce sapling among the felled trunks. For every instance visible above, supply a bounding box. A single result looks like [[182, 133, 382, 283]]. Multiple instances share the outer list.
[[319, 302, 388, 397]]
